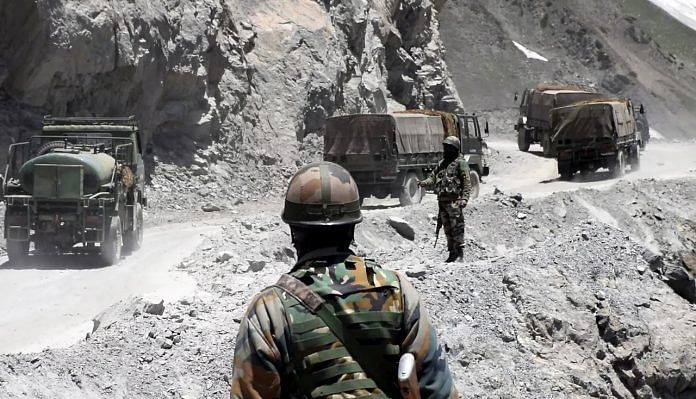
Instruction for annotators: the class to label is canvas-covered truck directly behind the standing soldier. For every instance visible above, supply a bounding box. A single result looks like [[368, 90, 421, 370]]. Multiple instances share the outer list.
[[324, 111, 490, 206]]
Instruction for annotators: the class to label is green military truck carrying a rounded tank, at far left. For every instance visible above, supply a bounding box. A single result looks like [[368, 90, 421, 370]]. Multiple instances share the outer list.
[[3, 116, 147, 265]]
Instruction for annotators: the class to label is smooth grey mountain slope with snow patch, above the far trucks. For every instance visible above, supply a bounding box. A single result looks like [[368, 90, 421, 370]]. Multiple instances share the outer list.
[[440, 0, 696, 139]]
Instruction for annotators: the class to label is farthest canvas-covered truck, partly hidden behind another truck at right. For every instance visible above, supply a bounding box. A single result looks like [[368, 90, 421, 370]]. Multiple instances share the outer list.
[[515, 84, 603, 157]]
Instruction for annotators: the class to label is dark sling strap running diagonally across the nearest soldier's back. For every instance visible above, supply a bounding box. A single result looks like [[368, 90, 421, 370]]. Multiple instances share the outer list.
[[275, 274, 396, 392]]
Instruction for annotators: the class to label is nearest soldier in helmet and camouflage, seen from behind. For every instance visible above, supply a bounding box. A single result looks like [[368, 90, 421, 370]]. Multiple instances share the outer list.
[[231, 162, 457, 399]]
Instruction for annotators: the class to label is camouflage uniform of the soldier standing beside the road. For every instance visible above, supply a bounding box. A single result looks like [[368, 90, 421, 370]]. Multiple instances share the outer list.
[[423, 156, 471, 252]]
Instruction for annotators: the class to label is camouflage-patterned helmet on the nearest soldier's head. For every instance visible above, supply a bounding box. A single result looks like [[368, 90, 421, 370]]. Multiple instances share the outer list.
[[281, 162, 362, 226]]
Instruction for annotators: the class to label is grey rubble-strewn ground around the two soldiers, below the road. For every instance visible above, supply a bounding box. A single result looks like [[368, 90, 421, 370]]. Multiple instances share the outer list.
[[0, 174, 696, 399]]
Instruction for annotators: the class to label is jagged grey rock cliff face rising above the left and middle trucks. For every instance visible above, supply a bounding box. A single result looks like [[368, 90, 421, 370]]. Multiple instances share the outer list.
[[0, 0, 458, 170]]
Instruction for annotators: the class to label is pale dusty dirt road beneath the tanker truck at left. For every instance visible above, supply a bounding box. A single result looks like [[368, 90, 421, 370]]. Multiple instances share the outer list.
[[0, 223, 219, 353]]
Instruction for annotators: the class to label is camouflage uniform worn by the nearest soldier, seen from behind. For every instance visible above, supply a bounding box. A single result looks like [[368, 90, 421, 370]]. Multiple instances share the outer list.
[[231, 250, 457, 399]]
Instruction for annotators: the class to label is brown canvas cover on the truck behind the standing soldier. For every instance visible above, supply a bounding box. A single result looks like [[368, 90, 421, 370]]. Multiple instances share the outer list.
[[324, 114, 445, 156]]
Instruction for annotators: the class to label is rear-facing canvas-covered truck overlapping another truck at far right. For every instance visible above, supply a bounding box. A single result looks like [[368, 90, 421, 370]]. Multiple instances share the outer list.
[[551, 99, 640, 180]]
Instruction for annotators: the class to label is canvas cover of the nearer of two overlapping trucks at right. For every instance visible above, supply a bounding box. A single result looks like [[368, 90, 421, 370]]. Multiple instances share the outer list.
[[551, 102, 635, 142]]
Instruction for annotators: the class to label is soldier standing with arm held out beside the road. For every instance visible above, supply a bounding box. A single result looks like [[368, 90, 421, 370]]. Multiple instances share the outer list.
[[418, 136, 471, 262]]
